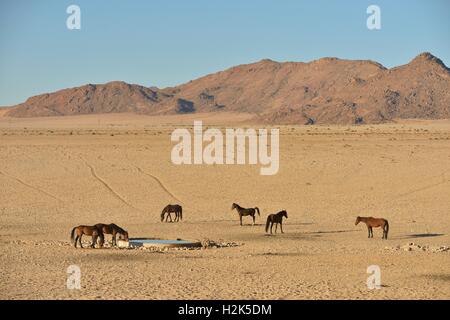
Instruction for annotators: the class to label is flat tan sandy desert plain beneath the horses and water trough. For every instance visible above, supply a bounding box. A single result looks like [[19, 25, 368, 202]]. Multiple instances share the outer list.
[[0, 114, 450, 299]]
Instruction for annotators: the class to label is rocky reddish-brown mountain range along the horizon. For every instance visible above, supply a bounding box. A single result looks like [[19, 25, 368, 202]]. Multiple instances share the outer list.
[[6, 53, 450, 124]]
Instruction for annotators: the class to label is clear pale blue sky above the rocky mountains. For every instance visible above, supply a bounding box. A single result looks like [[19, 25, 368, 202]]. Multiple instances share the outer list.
[[0, 0, 450, 106]]
